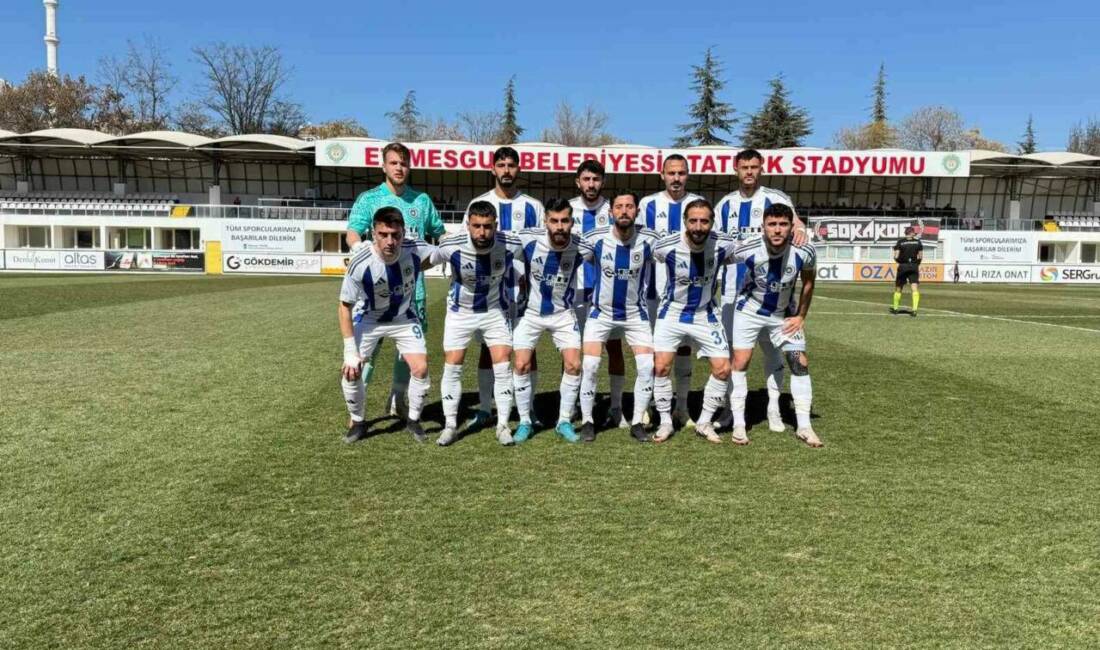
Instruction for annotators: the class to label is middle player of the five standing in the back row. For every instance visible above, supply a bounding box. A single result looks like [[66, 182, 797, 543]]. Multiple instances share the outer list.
[[570, 161, 624, 427]]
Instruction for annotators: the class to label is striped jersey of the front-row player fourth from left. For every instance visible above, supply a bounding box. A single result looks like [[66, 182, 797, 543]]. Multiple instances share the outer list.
[[585, 225, 659, 321]]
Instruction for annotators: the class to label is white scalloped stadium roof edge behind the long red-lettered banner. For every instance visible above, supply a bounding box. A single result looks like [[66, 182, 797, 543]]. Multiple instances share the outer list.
[[0, 129, 1100, 175]]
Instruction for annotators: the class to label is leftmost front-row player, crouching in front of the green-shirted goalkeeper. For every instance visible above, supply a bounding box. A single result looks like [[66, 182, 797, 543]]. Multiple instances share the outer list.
[[338, 206, 436, 442]]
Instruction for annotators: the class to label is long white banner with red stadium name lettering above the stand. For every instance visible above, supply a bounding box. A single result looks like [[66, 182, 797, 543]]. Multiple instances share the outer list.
[[315, 139, 970, 177]]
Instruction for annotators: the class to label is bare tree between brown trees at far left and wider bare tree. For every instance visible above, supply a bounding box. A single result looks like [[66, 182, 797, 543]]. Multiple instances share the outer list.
[[99, 35, 178, 130]]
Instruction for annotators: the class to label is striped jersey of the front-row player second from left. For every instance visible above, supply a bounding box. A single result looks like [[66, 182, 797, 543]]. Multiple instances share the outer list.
[[431, 231, 524, 313]]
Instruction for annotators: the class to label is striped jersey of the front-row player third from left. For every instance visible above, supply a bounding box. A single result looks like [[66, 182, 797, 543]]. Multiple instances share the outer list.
[[517, 228, 593, 316]]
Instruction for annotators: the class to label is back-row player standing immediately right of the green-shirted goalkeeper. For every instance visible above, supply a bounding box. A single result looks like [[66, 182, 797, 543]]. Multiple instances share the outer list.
[[463, 146, 545, 427]]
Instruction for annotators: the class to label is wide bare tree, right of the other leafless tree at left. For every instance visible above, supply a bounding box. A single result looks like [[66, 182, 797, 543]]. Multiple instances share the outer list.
[[194, 43, 305, 134]]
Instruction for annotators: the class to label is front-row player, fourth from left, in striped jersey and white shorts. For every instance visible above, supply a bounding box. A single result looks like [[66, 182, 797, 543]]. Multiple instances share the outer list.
[[581, 190, 658, 442]]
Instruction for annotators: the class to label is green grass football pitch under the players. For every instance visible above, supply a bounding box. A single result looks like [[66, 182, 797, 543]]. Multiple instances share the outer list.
[[0, 275, 1100, 648]]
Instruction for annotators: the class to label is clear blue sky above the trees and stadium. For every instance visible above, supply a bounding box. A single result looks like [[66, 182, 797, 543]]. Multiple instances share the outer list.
[[0, 0, 1100, 150]]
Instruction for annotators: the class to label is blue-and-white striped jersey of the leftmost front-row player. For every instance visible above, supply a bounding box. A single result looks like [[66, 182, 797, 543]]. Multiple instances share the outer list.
[[340, 240, 436, 322]]
